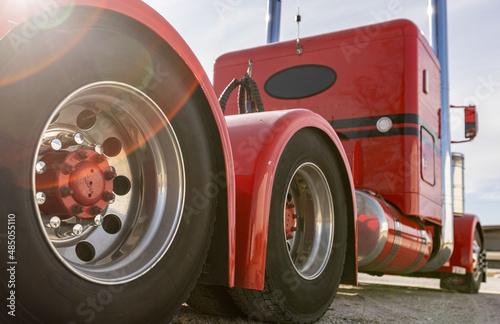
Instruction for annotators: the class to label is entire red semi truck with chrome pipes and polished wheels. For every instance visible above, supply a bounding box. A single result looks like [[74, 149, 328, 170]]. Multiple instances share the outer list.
[[0, 0, 486, 323]]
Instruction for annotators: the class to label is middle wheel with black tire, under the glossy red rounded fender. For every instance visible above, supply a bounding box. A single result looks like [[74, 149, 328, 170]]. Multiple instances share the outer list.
[[231, 129, 347, 323]]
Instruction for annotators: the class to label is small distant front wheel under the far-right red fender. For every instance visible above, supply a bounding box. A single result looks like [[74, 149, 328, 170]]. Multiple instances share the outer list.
[[440, 229, 486, 294]]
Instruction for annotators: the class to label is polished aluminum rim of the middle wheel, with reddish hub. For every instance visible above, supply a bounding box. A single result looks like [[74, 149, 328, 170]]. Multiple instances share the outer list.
[[284, 163, 334, 280]]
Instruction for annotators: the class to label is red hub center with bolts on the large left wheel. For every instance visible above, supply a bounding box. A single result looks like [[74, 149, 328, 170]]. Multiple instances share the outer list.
[[36, 150, 116, 218]]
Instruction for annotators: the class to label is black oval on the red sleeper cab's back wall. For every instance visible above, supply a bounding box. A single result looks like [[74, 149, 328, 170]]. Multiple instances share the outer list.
[[264, 64, 337, 99]]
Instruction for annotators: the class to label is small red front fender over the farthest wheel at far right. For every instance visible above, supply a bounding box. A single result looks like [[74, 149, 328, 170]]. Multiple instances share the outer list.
[[450, 214, 484, 273]]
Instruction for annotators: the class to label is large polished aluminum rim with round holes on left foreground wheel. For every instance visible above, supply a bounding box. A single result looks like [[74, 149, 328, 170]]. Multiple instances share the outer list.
[[33, 82, 185, 284]]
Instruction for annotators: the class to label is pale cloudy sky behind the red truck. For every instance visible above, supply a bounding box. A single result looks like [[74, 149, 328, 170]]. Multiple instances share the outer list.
[[145, 0, 500, 225]]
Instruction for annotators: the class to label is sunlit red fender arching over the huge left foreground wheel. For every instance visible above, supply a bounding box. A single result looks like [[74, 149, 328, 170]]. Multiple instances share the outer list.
[[0, 0, 235, 286]]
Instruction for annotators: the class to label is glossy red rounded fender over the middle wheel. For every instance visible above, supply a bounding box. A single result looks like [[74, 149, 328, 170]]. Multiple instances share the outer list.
[[226, 109, 357, 290]]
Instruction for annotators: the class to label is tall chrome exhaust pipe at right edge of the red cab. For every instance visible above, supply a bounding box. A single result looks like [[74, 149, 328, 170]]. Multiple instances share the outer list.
[[420, 0, 454, 271]]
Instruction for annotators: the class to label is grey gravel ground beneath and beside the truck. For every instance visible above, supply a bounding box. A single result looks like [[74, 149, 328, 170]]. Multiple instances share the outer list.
[[172, 273, 500, 324]]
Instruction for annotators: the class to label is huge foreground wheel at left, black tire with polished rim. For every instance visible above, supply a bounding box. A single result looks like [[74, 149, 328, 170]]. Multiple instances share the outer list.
[[0, 8, 216, 323]]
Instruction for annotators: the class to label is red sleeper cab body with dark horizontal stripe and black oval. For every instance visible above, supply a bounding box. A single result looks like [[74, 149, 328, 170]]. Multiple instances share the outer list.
[[214, 20, 442, 224]]
